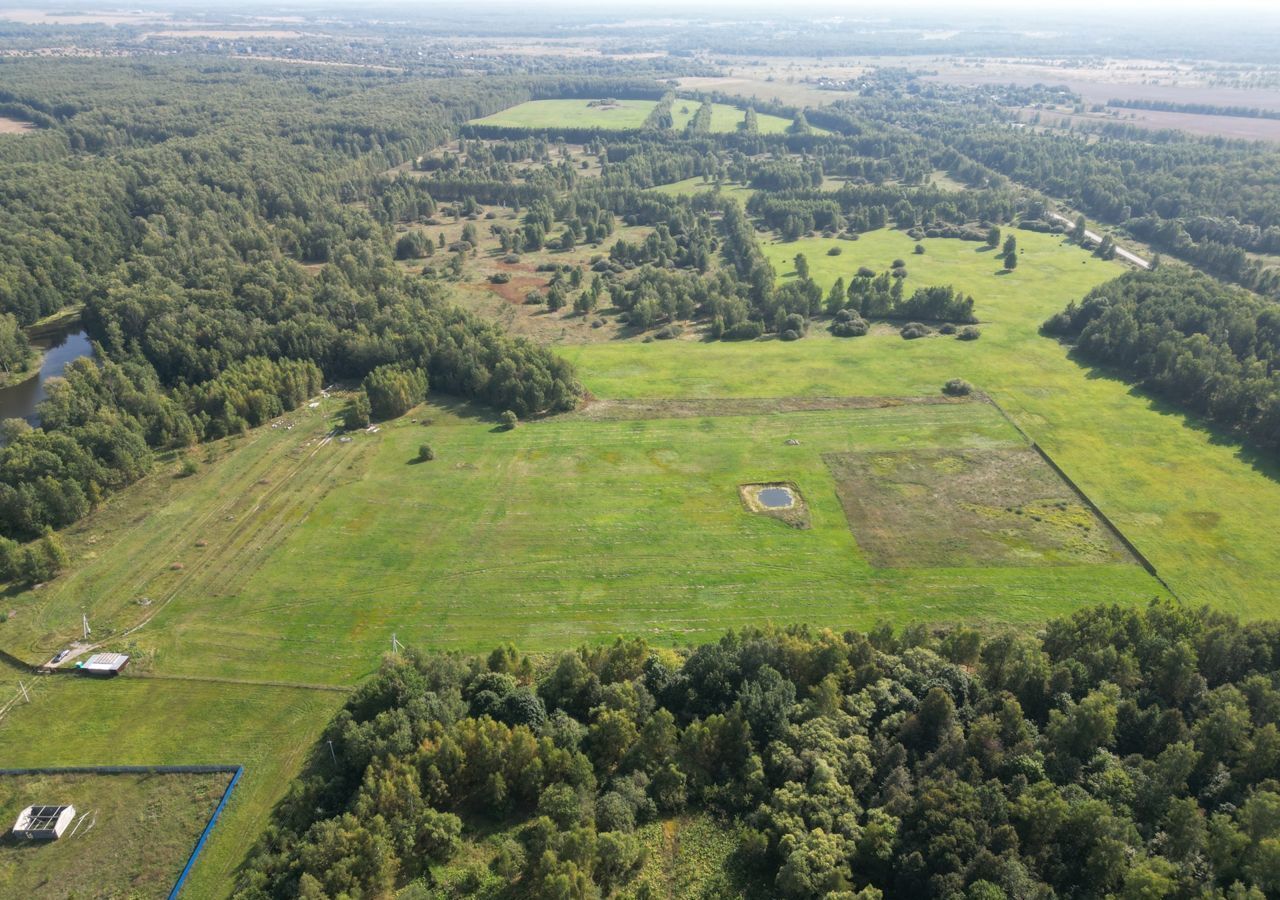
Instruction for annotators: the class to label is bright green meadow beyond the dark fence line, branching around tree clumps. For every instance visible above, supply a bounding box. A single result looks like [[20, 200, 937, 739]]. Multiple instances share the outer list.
[[557, 229, 1280, 618]]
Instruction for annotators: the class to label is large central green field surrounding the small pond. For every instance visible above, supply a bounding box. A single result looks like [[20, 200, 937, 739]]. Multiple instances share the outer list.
[[4, 394, 1160, 684]]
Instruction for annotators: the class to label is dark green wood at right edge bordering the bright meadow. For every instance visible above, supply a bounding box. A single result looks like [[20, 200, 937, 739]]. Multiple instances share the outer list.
[[1044, 266, 1280, 449]]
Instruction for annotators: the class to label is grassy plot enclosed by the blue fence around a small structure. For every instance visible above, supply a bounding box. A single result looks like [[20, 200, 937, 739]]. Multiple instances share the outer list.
[[0, 772, 232, 900]]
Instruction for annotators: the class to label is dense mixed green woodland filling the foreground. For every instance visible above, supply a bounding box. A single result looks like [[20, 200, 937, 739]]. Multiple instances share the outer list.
[[237, 603, 1280, 900]]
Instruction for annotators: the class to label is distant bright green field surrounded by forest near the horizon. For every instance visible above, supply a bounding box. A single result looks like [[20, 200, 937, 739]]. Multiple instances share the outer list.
[[467, 99, 803, 134]]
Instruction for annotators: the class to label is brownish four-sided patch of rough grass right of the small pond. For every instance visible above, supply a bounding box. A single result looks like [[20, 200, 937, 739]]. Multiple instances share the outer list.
[[823, 447, 1135, 568]]
